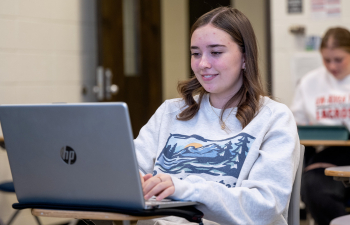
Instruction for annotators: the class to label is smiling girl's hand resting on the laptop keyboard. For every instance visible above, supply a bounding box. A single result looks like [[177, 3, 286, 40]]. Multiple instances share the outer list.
[[142, 174, 175, 201]]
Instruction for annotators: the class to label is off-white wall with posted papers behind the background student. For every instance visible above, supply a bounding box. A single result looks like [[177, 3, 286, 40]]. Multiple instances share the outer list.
[[271, 0, 350, 105]]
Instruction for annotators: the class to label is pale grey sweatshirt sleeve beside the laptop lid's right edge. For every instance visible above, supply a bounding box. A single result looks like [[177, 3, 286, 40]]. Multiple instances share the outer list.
[[134, 102, 167, 174]]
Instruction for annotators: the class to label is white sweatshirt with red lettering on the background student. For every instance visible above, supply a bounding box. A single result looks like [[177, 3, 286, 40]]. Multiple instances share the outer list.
[[291, 67, 350, 129]]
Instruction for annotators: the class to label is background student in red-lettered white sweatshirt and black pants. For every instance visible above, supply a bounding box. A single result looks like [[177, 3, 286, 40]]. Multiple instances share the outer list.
[[291, 27, 350, 225]]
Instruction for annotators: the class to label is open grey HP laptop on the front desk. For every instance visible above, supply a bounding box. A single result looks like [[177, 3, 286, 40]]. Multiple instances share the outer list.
[[0, 102, 196, 209]]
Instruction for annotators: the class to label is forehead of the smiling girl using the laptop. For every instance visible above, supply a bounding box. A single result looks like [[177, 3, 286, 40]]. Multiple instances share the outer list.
[[191, 24, 234, 45]]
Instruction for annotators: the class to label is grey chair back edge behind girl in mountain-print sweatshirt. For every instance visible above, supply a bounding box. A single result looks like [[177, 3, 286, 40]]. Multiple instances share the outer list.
[[288, 145, 305, 225]]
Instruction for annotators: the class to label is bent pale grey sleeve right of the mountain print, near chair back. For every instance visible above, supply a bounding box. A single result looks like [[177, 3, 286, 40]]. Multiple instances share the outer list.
[[172, 106, 300, 225]]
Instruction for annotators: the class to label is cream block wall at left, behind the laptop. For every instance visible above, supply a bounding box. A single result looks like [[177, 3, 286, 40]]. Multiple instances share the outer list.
[[0, 0, 96, 225]]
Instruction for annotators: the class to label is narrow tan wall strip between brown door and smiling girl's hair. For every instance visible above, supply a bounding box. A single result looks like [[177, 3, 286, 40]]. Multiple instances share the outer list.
[[161, 0, 190, 100]]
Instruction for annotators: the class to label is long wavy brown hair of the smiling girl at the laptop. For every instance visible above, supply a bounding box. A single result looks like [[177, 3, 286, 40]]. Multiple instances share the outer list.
[[177, 7, 265, 128]]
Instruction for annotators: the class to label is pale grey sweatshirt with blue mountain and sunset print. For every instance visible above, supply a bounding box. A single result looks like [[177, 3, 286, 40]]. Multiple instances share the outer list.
[[135, 95, 300, 225]]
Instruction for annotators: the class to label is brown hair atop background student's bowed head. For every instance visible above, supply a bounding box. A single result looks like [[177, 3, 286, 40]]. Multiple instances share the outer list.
[[320, 27, 350, 53]]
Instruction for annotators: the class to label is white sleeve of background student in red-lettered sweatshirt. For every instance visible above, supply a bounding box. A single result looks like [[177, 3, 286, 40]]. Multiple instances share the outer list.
[[290, 83, 309, 125]]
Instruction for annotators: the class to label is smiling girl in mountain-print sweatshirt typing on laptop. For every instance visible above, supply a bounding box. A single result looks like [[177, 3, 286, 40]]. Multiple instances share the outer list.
[[135, 7, 300, 225]]
